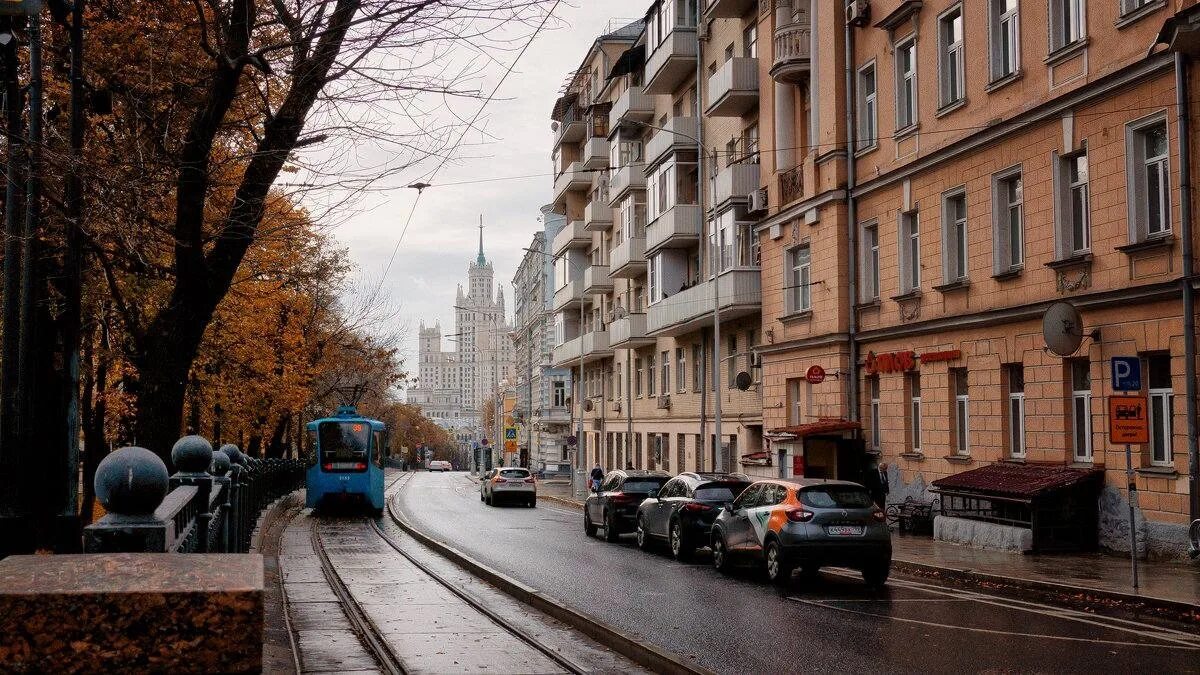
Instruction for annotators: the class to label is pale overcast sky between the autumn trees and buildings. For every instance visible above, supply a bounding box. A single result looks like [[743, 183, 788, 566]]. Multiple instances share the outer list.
[[335, 0, 649, 384]]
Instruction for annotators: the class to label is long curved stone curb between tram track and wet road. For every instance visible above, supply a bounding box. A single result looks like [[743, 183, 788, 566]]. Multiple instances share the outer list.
[[388, 496, 713, 675]]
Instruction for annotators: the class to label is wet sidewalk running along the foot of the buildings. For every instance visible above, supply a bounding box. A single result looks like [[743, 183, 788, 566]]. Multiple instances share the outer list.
[[540, 484, 1200, 617]]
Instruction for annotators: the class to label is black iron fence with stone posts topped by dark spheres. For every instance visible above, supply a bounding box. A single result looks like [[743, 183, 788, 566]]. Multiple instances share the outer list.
[[83, 436, 305, 552]]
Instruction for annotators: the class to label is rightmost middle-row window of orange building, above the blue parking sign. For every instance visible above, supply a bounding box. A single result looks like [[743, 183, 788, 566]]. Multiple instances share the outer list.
[[1126, 115, 1171, 243]]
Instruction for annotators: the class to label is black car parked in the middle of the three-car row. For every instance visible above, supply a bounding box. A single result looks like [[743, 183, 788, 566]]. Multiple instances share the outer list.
[[637, 472, 751, 561]]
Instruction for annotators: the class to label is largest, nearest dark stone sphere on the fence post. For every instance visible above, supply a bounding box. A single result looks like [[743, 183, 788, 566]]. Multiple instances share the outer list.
[[95, 447, 168, 515]]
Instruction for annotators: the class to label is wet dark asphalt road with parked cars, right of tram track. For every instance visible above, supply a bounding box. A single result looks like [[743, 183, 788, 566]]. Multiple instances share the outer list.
[[396, 473, 1200, 673]]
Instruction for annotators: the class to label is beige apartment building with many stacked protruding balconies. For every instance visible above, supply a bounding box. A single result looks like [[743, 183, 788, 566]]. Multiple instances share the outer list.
[[552, 7, 762, 471]]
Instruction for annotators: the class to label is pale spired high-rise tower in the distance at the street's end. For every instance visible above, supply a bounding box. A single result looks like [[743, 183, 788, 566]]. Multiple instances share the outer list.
[[409, 223, 514, 448]]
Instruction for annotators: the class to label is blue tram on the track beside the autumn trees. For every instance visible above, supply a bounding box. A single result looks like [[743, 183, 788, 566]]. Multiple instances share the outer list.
[[306, 406, 388, 515]]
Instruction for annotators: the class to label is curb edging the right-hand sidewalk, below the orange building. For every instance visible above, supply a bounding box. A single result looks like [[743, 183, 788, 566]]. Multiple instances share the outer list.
[[892, 557, 1200, 623]]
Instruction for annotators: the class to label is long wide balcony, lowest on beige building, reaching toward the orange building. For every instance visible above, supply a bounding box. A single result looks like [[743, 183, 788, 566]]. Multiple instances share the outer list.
[[646, 268, 762, 338]]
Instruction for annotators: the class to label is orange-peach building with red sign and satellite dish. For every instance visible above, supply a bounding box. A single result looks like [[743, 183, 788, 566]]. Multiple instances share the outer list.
[[758, 0, 1195, 555]]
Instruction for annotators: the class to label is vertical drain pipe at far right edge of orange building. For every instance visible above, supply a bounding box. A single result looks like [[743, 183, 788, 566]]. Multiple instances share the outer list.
[[1175, 52, 1200, 520]]
